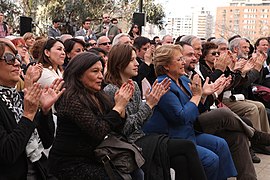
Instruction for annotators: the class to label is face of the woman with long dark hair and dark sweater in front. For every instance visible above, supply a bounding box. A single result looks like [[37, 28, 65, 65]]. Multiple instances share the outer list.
[[81, 61, 103, 91]]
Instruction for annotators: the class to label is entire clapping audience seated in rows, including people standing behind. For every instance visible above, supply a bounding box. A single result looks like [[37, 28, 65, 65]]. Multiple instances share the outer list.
[[0, 10, 270, 180]]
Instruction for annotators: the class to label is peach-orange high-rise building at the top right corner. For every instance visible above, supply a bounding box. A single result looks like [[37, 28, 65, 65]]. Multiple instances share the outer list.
[[215, 0, 270, 42]]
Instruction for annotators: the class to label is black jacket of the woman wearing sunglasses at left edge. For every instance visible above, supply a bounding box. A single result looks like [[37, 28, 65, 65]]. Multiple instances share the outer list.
[[0, 99, 54, 180]]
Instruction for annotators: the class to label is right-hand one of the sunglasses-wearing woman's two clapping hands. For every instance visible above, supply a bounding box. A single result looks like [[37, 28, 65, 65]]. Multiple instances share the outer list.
[[39, 78, 65, 114]]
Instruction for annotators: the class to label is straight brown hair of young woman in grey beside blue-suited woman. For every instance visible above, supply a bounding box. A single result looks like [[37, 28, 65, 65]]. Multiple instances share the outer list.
[[105, 44, 135, 87]]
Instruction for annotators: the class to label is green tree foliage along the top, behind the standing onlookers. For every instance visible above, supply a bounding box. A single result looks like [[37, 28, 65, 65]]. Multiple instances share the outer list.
[[0, 0, 165, 34]]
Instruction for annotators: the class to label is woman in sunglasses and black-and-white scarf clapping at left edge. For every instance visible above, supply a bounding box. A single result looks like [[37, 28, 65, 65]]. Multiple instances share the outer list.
[[0, 38, 64, 180]]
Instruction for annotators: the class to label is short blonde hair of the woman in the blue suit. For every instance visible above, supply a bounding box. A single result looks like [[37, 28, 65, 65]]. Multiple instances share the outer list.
[[153, 44, 182, 76]]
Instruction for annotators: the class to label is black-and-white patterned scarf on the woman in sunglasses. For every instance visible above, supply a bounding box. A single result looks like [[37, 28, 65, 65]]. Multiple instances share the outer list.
[[0, 86, 44, 162]]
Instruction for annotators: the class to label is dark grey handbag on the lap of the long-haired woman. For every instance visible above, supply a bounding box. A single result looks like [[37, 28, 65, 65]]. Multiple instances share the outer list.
[[94, 133, 145, 180]]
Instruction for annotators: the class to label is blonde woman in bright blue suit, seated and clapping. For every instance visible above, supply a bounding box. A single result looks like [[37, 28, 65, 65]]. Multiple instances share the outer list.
[[144, 45, 237, 180]]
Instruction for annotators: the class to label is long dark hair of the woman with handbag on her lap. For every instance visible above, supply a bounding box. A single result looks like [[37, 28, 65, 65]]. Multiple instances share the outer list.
[[56, 52, 112, 114]]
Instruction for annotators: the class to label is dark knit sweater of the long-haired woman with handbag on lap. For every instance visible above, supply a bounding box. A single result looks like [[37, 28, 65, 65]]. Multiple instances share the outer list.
[[49, 95, 125, 179]]
